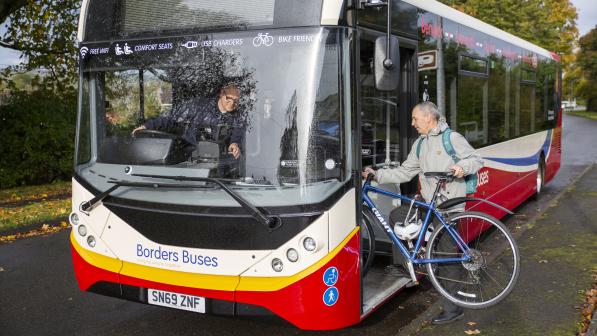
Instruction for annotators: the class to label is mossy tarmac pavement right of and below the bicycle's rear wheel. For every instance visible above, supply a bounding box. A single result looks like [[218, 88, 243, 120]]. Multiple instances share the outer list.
[[398, 164, 597, 336]]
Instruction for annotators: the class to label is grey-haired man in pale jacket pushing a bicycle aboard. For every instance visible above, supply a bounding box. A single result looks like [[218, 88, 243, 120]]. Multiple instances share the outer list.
[[362, 102, 483, 324]]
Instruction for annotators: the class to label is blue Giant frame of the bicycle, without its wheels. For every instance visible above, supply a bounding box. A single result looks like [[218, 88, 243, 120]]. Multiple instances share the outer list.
[[361, 183, 471, 264]]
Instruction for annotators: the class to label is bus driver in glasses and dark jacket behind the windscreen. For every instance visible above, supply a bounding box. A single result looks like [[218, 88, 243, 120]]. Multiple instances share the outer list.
[[133, 84, 245, 159]]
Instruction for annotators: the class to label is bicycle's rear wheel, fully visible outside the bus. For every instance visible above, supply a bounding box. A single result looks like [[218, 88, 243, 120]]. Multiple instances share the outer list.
[[427, 212, 520, 309]]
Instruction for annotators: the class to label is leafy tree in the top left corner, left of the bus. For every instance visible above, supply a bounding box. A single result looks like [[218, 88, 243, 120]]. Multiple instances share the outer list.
[[0, 0, 80, 91]]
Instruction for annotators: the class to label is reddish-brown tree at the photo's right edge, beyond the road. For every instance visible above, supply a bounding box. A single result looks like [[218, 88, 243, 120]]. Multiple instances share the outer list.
[[577, 25, 597, 112]]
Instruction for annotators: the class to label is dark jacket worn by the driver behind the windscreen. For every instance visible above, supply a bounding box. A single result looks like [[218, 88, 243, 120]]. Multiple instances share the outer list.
[[145, 98, 245, 146]]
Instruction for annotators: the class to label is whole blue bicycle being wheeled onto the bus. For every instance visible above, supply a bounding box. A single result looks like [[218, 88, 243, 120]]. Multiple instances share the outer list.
[[361, 172, 520, 309]]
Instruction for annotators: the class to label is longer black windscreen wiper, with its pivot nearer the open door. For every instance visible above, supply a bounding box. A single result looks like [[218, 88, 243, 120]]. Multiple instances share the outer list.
[[131, 174, 282, 232]]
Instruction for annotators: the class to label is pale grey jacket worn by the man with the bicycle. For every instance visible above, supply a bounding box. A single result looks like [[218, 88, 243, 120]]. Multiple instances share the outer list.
[[375, 121, 483, 203]]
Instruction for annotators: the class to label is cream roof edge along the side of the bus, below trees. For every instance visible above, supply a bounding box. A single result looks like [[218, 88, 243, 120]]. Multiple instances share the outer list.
[[402, 0, 560, 62]]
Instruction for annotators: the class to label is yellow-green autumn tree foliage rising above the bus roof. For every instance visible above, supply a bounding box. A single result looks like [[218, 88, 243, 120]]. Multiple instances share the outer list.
[[440, 0, 578, 65]]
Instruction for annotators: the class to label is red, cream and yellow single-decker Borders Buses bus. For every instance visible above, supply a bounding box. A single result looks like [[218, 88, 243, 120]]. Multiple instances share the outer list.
[[69, 0, 562, 330]]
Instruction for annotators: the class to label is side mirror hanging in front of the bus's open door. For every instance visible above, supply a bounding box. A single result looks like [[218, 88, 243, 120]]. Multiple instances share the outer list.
[[373, 36, 400, 91]]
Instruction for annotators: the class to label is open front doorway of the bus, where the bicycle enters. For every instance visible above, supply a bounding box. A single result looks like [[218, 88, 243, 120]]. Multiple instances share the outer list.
[[358, 30, 417, 314]]
